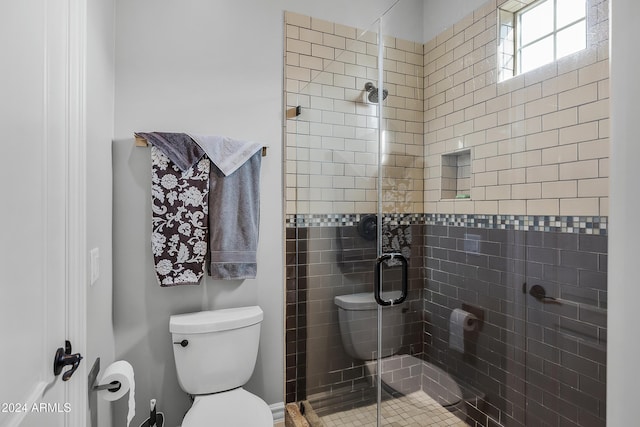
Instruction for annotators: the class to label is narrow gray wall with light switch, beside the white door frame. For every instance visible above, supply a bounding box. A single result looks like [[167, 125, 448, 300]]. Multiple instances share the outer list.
[[83, 0, 115, 427]]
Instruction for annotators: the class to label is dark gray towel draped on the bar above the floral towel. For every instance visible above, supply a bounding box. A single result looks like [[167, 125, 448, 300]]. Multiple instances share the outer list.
[[136, 132, 204, 172]]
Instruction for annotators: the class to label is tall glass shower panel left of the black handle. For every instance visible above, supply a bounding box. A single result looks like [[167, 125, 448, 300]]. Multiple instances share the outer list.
[[285, 13, 379, 427]]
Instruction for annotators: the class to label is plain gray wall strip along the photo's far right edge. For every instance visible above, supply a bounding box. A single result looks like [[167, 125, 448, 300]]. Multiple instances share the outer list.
[[607, 0, 640, 426]]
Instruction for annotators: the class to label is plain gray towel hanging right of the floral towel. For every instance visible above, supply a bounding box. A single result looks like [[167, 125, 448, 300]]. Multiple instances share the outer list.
[[209, 151, 262, 279]]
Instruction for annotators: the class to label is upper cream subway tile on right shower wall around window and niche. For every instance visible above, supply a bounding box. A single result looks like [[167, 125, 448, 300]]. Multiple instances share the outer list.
[[424, 0, 609, 215]]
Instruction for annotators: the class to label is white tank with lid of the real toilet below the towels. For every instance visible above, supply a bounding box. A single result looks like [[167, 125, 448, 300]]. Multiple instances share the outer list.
[[169, 306, 263, 395]]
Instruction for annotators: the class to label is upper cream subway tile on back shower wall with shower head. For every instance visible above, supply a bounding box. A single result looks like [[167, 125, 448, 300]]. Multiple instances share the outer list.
[[285, 12, 425, 214]]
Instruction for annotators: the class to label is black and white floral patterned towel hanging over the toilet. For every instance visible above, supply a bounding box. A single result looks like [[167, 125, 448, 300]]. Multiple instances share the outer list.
[[151, 146, 210, 286]]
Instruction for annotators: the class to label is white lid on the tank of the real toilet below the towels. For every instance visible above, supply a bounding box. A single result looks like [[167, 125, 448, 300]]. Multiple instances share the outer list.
[[169, 305, 264, 334]]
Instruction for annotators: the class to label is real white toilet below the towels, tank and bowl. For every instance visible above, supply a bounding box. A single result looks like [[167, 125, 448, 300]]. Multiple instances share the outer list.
[[169, 306, 273, 427]]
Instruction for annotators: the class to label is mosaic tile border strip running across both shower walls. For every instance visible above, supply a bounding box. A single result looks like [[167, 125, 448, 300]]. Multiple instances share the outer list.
[[286, 213, 609, 235]]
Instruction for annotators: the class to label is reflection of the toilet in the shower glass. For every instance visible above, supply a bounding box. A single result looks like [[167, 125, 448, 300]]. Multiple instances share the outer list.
[[334, 291, 466, 419]]
